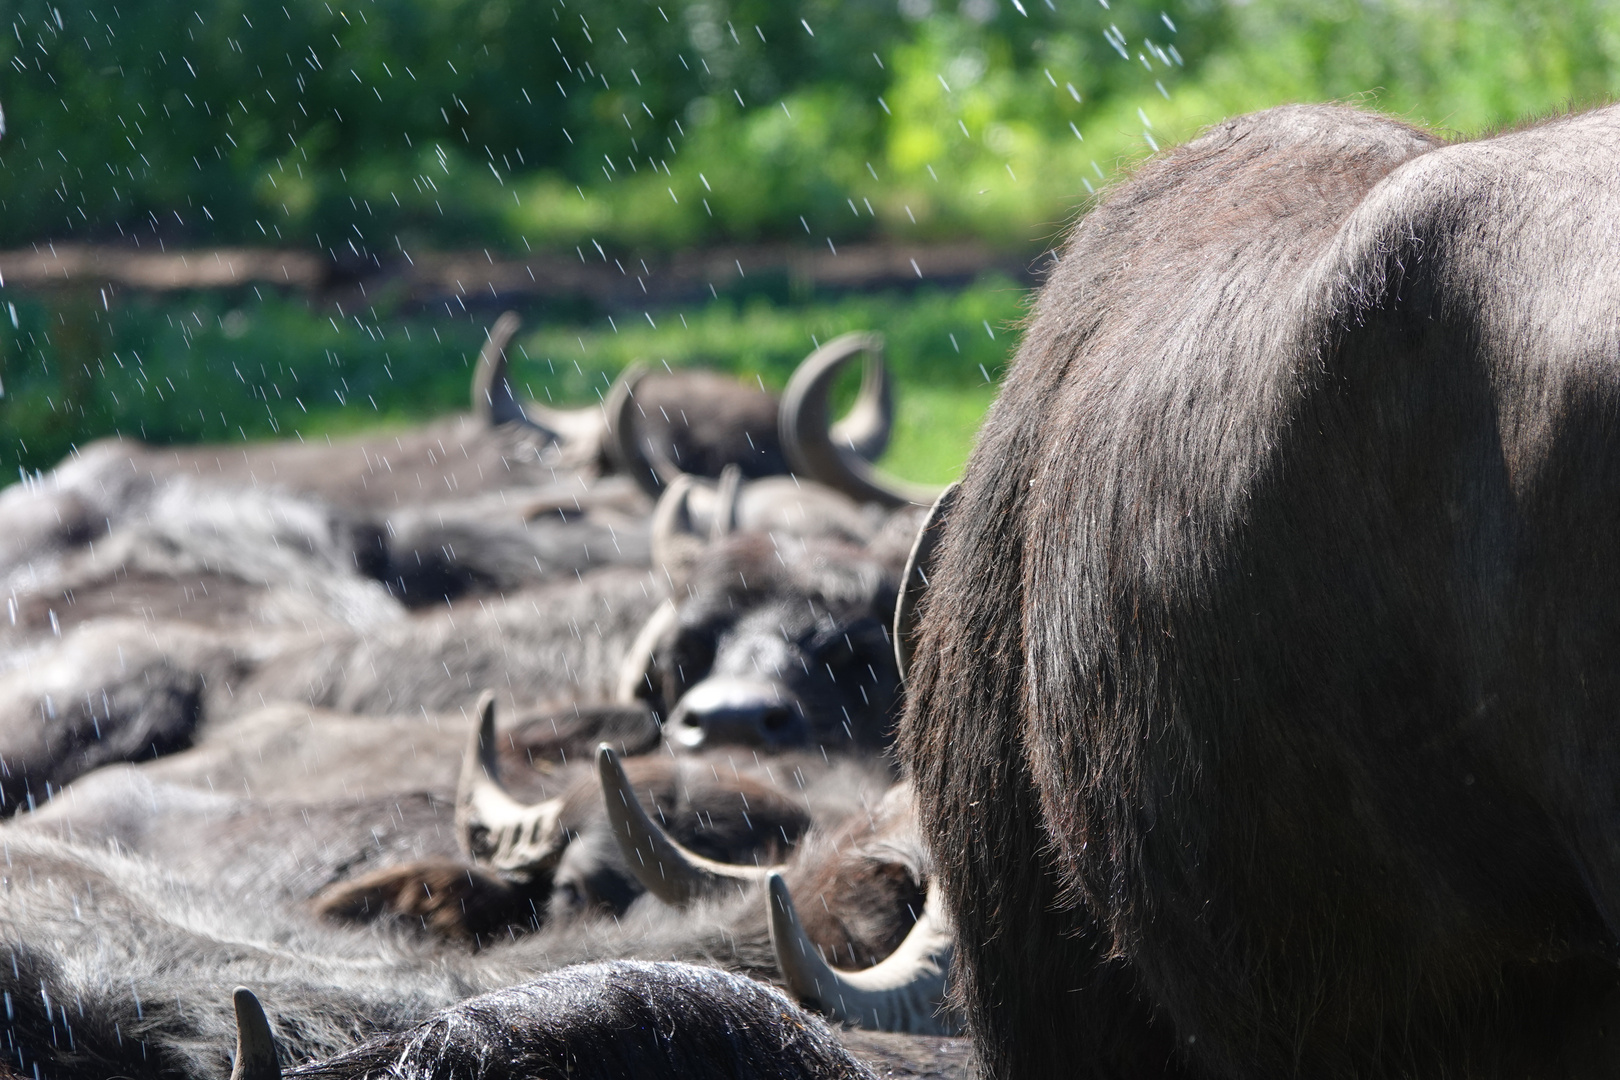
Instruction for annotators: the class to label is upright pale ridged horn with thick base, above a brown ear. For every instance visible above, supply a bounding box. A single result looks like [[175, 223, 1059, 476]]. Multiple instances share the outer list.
[[455, 690, 564, 876]]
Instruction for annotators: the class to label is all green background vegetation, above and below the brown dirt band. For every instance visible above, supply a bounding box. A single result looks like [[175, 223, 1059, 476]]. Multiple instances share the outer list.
[[12, 0, 1620, 479]]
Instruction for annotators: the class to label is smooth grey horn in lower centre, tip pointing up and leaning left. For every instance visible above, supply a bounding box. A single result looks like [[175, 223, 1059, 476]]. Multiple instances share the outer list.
[[596, 743, 771, 907]]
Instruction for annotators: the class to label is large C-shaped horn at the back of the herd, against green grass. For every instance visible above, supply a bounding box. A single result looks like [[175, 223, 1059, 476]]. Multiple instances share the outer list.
[[779, 334, 940, 507]]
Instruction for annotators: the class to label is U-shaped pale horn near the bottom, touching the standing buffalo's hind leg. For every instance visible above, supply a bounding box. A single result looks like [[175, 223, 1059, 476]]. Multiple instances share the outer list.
[[766, 873, 957, 1035]]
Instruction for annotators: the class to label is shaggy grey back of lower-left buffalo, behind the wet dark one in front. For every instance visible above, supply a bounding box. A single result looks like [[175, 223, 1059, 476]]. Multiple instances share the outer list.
[[0, 827, 816, 1080]]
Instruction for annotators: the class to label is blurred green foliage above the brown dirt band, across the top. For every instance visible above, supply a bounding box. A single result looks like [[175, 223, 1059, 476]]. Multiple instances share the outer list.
[[0, 0, 1620, 257]]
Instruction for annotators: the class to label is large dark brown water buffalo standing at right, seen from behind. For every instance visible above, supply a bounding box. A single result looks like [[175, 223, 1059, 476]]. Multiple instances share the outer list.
[[901, 107, 1620, 1078]]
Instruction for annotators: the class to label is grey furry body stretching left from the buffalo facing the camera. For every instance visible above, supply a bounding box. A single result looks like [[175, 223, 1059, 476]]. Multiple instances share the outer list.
[[0, 568, 663, 813]]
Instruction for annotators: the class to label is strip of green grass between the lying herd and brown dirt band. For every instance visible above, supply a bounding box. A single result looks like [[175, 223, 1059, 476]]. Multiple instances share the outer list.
[[0, 277, 1025, 481]]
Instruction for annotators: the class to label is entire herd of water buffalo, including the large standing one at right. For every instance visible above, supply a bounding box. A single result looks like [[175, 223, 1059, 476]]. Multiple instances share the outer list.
[[0, 105, 1620, 1080]]
